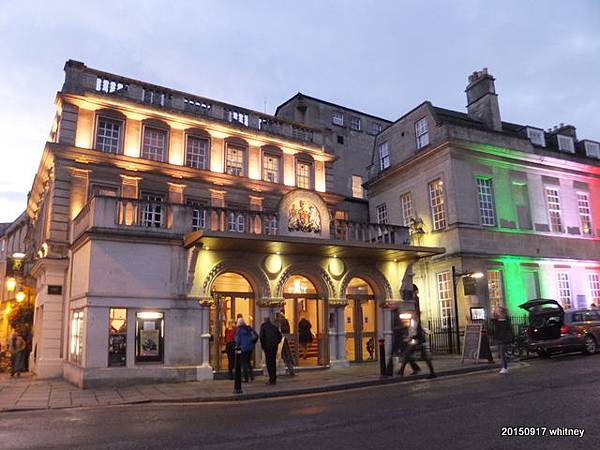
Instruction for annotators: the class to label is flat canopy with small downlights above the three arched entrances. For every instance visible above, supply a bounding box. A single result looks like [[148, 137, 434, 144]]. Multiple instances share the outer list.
[[184, 231, 446, 261]]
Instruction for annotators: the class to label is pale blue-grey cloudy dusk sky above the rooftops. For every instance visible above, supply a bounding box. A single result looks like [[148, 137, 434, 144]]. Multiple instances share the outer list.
[[0, 0, 600, 222]]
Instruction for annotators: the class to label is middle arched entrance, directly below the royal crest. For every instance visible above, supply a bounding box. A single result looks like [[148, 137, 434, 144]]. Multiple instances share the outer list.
[[283, 275, 328, 366]]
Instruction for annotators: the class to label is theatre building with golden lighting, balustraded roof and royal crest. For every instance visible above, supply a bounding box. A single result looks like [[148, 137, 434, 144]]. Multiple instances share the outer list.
[[17, 61, 443, 386]]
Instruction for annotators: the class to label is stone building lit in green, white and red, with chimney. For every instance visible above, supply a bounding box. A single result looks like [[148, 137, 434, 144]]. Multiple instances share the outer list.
[[367, 69, 600, 325]]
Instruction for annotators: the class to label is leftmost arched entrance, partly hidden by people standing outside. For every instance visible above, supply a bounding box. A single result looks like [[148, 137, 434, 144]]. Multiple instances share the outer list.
[[210, 272, 255, 372]]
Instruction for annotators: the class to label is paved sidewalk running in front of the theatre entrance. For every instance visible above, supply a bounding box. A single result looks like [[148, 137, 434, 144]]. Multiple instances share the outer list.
[[0, 355, 510, 412]]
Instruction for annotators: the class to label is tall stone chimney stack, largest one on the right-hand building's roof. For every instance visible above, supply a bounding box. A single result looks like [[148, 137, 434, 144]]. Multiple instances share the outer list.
[[465, 67, 502, 131]]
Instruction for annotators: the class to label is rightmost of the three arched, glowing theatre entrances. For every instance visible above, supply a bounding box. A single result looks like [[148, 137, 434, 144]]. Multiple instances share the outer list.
[[344, 277, 377, 361]]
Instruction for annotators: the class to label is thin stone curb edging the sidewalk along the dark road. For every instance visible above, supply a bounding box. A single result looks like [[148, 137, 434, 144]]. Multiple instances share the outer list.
[[0, 363, 510, 414]]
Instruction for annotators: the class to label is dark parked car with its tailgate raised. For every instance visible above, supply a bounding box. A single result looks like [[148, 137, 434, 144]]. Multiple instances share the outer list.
[[519, 298, 600, 357]]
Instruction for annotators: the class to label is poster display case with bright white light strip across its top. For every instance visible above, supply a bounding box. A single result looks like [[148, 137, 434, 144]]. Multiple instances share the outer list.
[[135, 311, 165, 362]]
